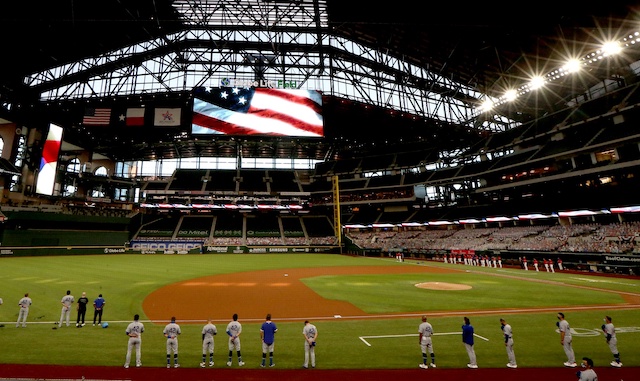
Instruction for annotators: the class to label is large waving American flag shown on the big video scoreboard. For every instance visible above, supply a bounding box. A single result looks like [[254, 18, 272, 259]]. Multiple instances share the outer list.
[[191, 87, 324, 137]]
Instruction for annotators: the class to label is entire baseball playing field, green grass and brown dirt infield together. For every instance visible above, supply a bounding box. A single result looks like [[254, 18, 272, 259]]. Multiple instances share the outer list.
[[0, 254, 640, 380]]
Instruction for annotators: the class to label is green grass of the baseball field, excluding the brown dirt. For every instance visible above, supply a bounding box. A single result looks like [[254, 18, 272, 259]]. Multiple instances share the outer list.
[[0, 254, 640, 369]]
